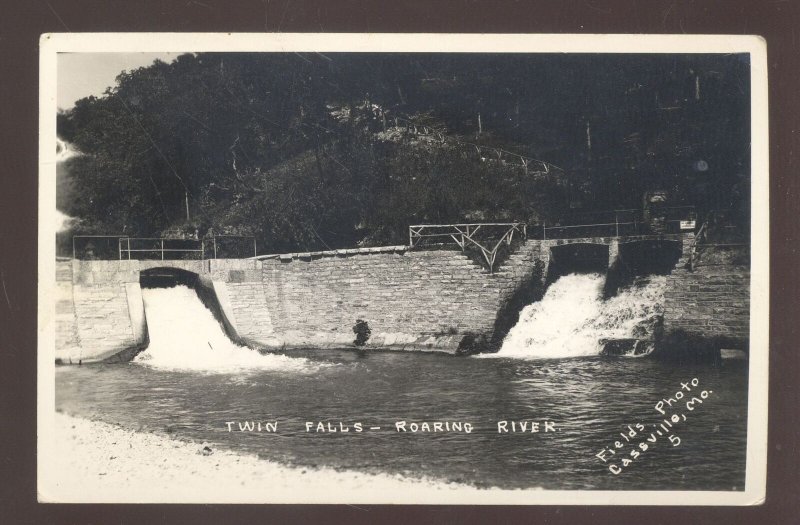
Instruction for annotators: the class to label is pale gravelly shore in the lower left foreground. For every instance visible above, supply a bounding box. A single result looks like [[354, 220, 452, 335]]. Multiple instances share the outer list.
[[39, 413, 510, 503]]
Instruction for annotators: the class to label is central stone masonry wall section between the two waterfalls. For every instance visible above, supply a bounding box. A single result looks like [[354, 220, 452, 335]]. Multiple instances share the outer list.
[[212, 241, 539, 352]]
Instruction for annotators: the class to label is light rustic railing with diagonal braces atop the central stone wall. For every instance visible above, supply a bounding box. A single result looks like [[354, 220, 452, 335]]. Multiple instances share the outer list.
[[408, 222, 528, 273]]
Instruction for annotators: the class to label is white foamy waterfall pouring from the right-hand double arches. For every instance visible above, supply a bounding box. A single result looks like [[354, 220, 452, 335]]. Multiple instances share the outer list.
[[481, 274, 666, 359]]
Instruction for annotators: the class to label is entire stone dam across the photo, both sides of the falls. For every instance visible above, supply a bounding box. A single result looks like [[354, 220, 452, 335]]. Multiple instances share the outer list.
[[55, 234, 749, 364]]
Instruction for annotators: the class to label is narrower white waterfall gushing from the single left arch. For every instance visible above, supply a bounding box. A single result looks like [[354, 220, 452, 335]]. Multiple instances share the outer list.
[[134, 285, 328, 373]]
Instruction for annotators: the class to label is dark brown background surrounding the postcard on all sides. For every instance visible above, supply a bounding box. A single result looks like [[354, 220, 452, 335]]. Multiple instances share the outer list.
[[0, 0, 800, 525]]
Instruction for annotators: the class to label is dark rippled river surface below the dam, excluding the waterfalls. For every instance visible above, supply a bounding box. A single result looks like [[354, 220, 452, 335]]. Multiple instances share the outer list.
[[56, 349, 747, 490]]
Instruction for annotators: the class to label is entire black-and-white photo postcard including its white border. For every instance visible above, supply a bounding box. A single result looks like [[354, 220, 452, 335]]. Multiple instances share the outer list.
[[37, 33, 769, 505]]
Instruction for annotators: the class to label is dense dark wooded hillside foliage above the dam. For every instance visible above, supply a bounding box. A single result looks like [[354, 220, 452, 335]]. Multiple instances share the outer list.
[[58, 53, 750, 252]]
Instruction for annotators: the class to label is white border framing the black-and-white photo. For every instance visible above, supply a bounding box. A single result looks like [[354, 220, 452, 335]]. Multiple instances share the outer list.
[[37, 33, 769, 505]]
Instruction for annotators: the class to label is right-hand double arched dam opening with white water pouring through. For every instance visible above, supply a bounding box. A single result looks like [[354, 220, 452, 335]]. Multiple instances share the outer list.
[[484, 241, 681, 359]]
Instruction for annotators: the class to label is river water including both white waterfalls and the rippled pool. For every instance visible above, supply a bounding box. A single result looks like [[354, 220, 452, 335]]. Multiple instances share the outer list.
[[56, 276, 747, 490]]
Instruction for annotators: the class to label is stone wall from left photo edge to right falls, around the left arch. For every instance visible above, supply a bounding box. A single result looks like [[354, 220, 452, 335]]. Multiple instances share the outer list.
[[58, 248, 549, 362]]
